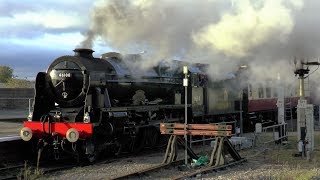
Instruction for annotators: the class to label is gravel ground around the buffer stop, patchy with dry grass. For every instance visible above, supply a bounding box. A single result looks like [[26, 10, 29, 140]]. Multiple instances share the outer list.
[[40, 133, 320, 179]]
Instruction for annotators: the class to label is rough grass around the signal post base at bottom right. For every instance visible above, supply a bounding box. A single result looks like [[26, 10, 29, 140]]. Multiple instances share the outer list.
[[248, 132, 320, 180]]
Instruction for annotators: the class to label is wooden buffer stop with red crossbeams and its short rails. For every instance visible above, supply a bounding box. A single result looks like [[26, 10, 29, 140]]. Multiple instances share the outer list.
[[114, 123, 245, 179]]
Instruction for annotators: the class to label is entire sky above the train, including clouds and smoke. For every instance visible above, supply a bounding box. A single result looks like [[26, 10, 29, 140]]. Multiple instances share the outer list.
[[0, 0, 320, 84]]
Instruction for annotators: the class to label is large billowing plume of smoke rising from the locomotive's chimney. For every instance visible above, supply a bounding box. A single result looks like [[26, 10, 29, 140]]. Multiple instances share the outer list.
[[81, 0, 304, 81]]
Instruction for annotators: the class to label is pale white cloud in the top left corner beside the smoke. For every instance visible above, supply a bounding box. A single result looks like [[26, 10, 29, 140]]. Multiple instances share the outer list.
[[0, 0, 93, 38]]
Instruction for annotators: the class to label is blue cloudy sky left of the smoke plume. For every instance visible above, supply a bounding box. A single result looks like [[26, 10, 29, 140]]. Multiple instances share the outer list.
[[0, 0, 110, 79]]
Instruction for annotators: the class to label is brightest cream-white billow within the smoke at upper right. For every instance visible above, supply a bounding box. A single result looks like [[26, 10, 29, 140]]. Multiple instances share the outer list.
[[193, 0, 302, 57]]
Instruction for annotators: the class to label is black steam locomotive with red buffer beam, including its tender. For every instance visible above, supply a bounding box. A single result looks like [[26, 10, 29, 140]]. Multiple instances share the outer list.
[[21, 49, 241, 160]]
